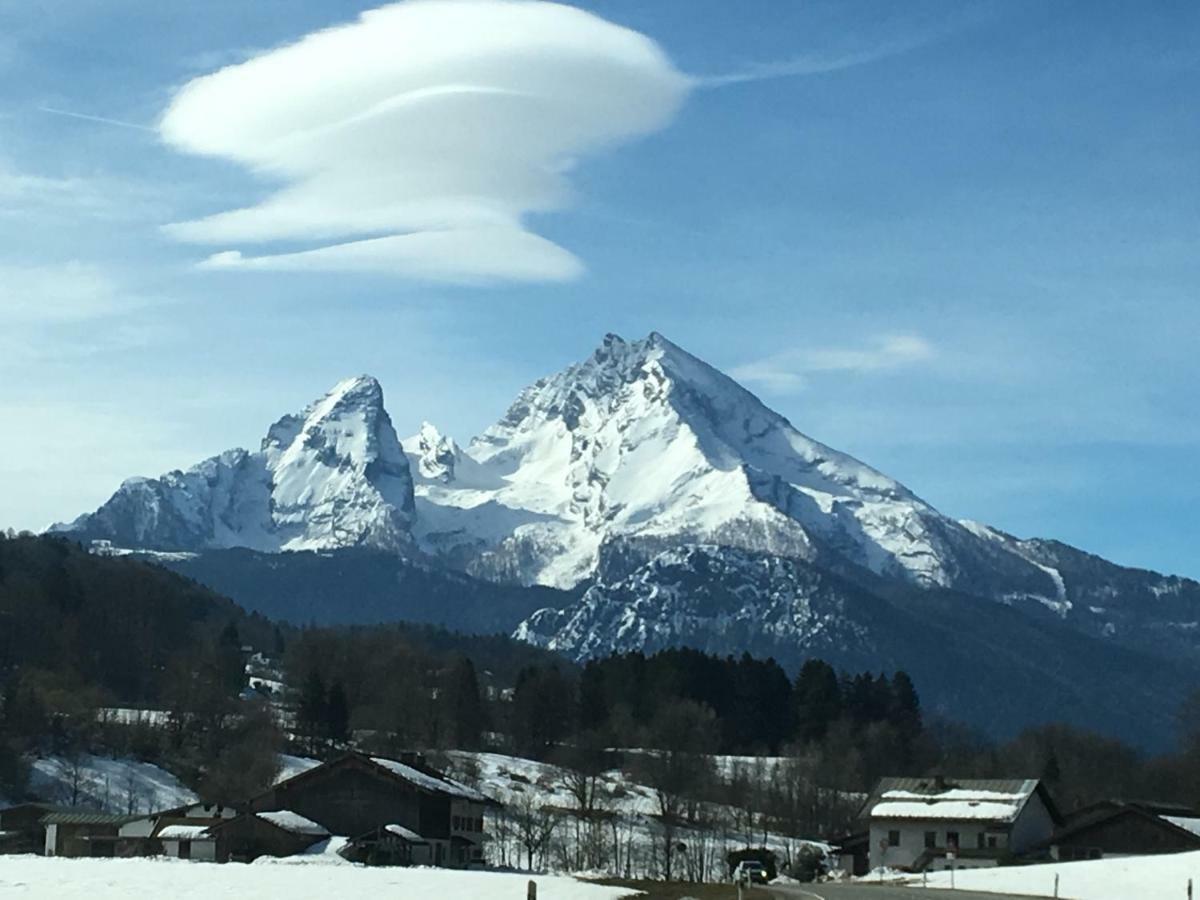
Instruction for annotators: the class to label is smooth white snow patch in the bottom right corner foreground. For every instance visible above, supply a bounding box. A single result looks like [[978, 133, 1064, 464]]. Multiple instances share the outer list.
[[907, 852, 1200, 900]]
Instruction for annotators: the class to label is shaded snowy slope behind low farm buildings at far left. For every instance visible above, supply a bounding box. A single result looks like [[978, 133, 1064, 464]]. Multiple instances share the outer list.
[[30, 754, 197, 814]]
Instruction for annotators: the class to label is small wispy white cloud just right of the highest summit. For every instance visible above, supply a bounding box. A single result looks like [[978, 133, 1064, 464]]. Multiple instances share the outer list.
[[731, 335, 936, 394]]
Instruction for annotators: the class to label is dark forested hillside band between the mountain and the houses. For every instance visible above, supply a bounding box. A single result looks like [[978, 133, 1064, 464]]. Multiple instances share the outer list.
[[0, 535, 1200, 830]]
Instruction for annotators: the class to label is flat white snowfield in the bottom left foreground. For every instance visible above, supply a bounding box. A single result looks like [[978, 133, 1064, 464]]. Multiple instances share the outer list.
[[0, 856, 629, 900]]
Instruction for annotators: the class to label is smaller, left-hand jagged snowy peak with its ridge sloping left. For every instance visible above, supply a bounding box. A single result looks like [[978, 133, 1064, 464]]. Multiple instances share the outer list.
[[58, 376, 415, 551]]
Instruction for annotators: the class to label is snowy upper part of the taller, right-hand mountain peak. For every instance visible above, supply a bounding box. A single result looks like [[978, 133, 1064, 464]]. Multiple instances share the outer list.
[[407, 334, 1060, 600]]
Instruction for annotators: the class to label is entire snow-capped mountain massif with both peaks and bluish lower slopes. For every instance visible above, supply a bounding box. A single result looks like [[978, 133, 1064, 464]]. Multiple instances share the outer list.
[[62, 334, 1200, 748]]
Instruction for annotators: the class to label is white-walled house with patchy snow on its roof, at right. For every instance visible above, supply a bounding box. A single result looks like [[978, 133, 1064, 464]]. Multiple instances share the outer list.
[[863, 776, 1062, 871]]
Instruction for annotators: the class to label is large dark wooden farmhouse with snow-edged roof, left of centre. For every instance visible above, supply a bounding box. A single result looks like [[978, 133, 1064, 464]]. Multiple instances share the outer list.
[[241, 751, 498, 868]]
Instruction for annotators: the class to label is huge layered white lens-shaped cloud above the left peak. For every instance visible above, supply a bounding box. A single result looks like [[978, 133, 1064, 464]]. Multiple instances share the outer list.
[[160, 0, 689, 282]]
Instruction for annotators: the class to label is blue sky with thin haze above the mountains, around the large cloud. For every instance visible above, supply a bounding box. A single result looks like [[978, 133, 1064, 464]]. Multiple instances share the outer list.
[[0, 0, 1200, 576]]
